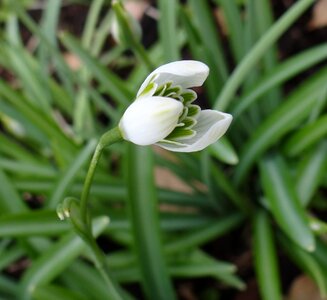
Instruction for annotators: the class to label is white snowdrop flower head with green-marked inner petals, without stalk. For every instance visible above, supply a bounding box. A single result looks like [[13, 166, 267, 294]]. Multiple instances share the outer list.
[[119, 60, 232, 152]]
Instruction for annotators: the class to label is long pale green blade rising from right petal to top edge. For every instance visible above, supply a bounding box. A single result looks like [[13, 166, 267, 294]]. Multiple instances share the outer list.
[[215, 0, 315, 110]]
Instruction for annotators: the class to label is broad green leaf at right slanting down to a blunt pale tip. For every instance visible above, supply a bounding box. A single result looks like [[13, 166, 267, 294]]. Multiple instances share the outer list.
[[260, 155, 315, 252]]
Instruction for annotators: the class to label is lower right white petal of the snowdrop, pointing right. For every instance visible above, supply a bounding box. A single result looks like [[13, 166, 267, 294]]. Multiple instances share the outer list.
[[157, 109, 233, 152]]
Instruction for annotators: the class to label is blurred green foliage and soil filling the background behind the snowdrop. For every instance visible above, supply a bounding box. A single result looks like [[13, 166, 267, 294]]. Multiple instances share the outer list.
[[0, 0, 327, 300]]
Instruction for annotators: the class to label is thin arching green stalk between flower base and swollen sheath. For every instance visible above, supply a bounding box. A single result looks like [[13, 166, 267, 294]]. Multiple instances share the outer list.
[[80, 127, 122, 229]]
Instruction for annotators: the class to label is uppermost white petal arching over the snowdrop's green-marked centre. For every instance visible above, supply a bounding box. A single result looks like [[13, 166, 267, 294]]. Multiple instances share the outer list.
[[137, 60, 209, 97]]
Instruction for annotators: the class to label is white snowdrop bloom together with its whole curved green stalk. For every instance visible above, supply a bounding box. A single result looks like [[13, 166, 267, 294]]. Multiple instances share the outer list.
[[57, 59, 232, 300]]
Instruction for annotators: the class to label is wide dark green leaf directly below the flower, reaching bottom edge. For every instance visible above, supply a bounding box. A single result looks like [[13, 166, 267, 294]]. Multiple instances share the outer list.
[[126, 143, 175, 300]]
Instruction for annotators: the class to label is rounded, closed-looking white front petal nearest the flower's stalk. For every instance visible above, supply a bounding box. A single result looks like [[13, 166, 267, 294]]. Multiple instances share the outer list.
[[119, 97, 183, 145]]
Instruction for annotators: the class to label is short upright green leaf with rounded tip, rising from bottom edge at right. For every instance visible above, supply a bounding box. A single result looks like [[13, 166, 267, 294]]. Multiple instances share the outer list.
[[253, 211, 283, 300]]
